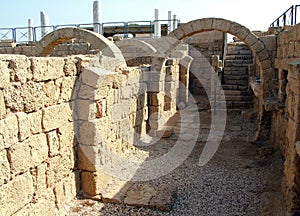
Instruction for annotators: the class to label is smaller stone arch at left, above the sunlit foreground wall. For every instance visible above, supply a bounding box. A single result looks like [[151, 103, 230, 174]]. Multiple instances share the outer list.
[[35, 28, 126, 68]]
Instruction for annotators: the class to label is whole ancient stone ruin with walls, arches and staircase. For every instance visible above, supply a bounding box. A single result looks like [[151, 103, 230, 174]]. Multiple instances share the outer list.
[[0, 11, 300, 215]]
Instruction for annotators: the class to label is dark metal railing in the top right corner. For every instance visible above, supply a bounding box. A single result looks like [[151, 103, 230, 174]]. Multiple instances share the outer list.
[[270, 5, 300, 27]]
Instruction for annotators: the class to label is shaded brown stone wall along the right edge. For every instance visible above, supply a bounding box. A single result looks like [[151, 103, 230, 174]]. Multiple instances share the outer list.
[[271, 24, 300, 215]]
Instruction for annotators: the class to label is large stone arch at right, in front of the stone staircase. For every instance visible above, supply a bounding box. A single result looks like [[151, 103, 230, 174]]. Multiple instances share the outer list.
[[168, 18, 274, 97]]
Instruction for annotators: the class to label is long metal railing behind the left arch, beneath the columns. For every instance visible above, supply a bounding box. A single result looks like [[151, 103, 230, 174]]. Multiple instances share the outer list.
[[0, 19, 180, 43]]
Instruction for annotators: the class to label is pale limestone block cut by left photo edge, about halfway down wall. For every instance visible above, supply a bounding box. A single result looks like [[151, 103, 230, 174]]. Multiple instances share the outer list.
[[0, 115, 19, 151]]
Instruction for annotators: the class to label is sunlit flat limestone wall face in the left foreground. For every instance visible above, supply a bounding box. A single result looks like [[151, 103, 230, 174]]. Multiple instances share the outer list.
[[0, 55, 79, 215]]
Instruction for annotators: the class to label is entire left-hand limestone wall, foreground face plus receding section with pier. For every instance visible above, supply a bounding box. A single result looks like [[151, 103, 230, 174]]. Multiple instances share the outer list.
[[0, 51, 179, 215]]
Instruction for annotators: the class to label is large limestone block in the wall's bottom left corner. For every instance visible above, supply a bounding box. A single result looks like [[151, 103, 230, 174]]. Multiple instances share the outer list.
[[0, 172, 34, 215]]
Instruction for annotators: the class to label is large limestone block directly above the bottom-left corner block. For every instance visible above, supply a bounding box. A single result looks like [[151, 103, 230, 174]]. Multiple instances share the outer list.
[[8, 134, 48, 173]]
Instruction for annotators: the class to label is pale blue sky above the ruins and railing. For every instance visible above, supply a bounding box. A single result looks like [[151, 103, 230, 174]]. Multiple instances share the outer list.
[[0, 0, 300, 30]]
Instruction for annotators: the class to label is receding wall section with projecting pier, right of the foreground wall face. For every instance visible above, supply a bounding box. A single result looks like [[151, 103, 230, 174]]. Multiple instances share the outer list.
[[76, 59, 179, 199]]
